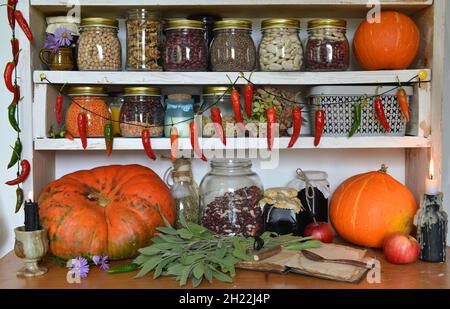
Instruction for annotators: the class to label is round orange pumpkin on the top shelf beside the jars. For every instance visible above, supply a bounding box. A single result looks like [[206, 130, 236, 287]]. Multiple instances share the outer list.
[[353, 11, 420, 70]]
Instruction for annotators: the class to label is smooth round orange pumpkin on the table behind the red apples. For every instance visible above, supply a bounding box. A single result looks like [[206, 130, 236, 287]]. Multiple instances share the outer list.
[[330, 168, 417, 248]]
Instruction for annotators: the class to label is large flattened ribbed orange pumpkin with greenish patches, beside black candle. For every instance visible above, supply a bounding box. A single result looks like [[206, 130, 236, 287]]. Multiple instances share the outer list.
[[39, 165, 176, 260]]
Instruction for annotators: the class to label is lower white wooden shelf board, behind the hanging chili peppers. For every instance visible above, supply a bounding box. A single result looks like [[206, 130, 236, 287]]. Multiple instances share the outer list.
[[34, 136, 431, 151]]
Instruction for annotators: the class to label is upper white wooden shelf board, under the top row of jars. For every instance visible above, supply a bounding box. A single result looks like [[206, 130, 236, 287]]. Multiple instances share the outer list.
[[33, 69, 431, 85]]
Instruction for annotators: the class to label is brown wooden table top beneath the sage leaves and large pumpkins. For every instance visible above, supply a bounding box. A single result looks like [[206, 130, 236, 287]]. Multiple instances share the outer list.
[[0, 249, 450, 289]]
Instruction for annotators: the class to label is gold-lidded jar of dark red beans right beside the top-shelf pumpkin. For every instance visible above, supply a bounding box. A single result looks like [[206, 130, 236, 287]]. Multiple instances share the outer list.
[[305, 19, 350, 71]]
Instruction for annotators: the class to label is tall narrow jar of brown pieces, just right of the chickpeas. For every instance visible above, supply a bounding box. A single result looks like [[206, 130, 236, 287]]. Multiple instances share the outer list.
[[126, 9, 162, 71]]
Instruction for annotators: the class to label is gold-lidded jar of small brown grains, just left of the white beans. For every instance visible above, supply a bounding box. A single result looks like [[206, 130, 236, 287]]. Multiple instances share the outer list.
[[210, 19, 256, 71]]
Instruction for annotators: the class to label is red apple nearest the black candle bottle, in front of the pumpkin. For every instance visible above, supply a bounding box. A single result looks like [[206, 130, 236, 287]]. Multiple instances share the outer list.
[[383, 233, 420, 264]]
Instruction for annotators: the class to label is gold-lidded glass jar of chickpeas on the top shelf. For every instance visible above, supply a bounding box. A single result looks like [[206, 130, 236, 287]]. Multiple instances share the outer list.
[[77, 17, 122, 71]]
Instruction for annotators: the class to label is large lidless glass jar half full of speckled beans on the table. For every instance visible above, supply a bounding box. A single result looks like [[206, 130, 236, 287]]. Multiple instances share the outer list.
[[200, 159, 263, 237]]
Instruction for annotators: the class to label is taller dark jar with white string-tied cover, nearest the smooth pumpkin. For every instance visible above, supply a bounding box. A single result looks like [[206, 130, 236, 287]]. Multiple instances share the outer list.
[[288, 169, 330, 235]]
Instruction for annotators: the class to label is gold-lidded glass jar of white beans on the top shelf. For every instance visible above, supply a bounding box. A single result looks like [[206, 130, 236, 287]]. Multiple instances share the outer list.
[[259, 19, 303, 71]]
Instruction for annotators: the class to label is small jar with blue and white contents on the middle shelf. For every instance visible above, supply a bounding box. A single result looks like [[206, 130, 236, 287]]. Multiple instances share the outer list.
[[164, 94, 195, 137]]
